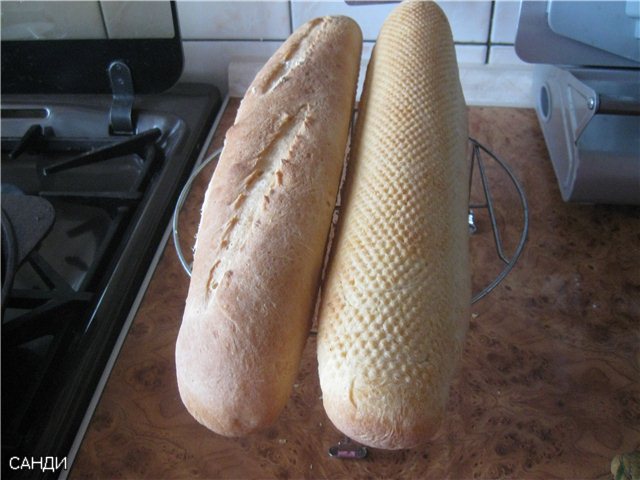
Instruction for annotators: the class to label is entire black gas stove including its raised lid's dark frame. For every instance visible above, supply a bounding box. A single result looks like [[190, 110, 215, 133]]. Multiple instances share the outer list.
[[1, 5, 221, 478]]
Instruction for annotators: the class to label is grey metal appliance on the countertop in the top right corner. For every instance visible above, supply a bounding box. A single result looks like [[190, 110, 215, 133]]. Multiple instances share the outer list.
[[515, 0, 640, 205]]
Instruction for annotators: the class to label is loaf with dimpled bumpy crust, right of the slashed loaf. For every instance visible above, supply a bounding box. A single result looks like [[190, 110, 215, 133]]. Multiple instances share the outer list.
[[318, 2, 471, 449]]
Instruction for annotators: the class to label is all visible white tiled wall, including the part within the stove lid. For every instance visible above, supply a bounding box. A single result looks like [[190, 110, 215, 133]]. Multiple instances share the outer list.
[[0, 0, 530, 104]]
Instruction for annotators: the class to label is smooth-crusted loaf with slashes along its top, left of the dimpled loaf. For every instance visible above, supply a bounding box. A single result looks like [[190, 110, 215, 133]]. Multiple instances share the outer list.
[[176, 17, 362, 436]]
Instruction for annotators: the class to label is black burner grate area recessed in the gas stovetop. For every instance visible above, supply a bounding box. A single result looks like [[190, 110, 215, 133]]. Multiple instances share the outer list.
[[2, 125, 165, 466]]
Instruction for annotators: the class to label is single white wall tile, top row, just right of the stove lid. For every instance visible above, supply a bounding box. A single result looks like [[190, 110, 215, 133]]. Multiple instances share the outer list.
[[177, 0, 291, 40]]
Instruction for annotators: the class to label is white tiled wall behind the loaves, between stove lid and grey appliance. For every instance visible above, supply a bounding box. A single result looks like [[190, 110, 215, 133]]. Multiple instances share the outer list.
[[178, 0, 530, 106]]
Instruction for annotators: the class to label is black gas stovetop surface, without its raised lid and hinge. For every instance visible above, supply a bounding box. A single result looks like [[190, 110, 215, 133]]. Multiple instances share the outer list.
[[1, 84, 220, 478]]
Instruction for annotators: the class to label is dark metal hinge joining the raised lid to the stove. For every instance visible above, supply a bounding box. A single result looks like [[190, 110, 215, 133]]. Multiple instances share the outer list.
[[108, 60, 135, 135]]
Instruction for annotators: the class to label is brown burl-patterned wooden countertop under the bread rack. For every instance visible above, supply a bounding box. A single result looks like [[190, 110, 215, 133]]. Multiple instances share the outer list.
[[71, 99, 640, 479]]
